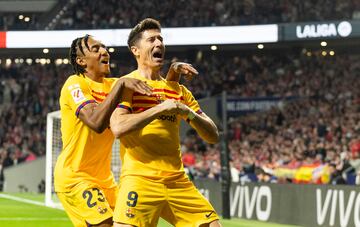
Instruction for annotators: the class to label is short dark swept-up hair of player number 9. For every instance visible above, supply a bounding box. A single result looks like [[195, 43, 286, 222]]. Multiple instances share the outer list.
[[128, 18, 161, 49]]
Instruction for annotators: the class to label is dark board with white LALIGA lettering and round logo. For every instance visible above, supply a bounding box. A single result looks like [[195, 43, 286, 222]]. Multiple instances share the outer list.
[[280, 20, 360, 41]]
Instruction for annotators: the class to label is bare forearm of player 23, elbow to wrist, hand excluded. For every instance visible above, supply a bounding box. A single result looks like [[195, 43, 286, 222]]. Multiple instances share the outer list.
[[85, 80, 124, 133]]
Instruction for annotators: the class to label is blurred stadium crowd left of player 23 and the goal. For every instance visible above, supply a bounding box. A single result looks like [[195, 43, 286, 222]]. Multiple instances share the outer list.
[[0, 64, 67, 188]]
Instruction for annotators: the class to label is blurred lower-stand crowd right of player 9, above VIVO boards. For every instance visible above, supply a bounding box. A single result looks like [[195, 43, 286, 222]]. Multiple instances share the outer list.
[[182, 52, 360, 184]]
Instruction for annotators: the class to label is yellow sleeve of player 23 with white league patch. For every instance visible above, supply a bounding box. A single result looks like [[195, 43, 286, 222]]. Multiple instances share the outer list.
[[61, 76, 96, 117]]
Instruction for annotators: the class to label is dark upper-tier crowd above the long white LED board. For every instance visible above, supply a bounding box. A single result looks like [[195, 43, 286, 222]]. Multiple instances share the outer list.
[[0, 0, 360, 30]]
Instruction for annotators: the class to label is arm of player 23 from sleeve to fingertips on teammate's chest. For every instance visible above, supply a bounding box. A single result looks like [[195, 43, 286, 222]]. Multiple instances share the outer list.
[[79, 78, 152, 133]]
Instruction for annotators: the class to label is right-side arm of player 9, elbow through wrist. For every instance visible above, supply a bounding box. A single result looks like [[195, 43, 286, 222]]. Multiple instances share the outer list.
[[178, 102, 219, 144]]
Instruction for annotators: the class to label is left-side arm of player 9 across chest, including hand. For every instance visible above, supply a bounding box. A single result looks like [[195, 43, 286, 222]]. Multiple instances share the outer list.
[[110, 99, 178, 138]]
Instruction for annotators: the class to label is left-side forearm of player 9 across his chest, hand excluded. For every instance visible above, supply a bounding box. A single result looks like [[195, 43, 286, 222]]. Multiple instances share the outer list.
[[110, 105, 163, 138]]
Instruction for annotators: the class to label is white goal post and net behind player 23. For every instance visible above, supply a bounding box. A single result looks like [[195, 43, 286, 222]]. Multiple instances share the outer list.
[[45, 111, 121, 208]]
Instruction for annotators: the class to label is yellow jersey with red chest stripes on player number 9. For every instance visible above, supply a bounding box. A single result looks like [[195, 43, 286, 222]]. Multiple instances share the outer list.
[[119, 70, 201, 182]]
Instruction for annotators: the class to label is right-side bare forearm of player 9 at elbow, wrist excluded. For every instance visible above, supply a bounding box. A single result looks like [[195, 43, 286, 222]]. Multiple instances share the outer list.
[[190, 113, 219, 144]]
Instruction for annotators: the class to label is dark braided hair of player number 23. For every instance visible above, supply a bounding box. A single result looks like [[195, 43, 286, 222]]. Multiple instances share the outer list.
[[69, 35, 91, 75]]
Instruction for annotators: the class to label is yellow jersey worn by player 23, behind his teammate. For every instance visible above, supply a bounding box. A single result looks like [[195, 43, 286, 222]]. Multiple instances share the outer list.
[[54, 75, 117, 192]]
